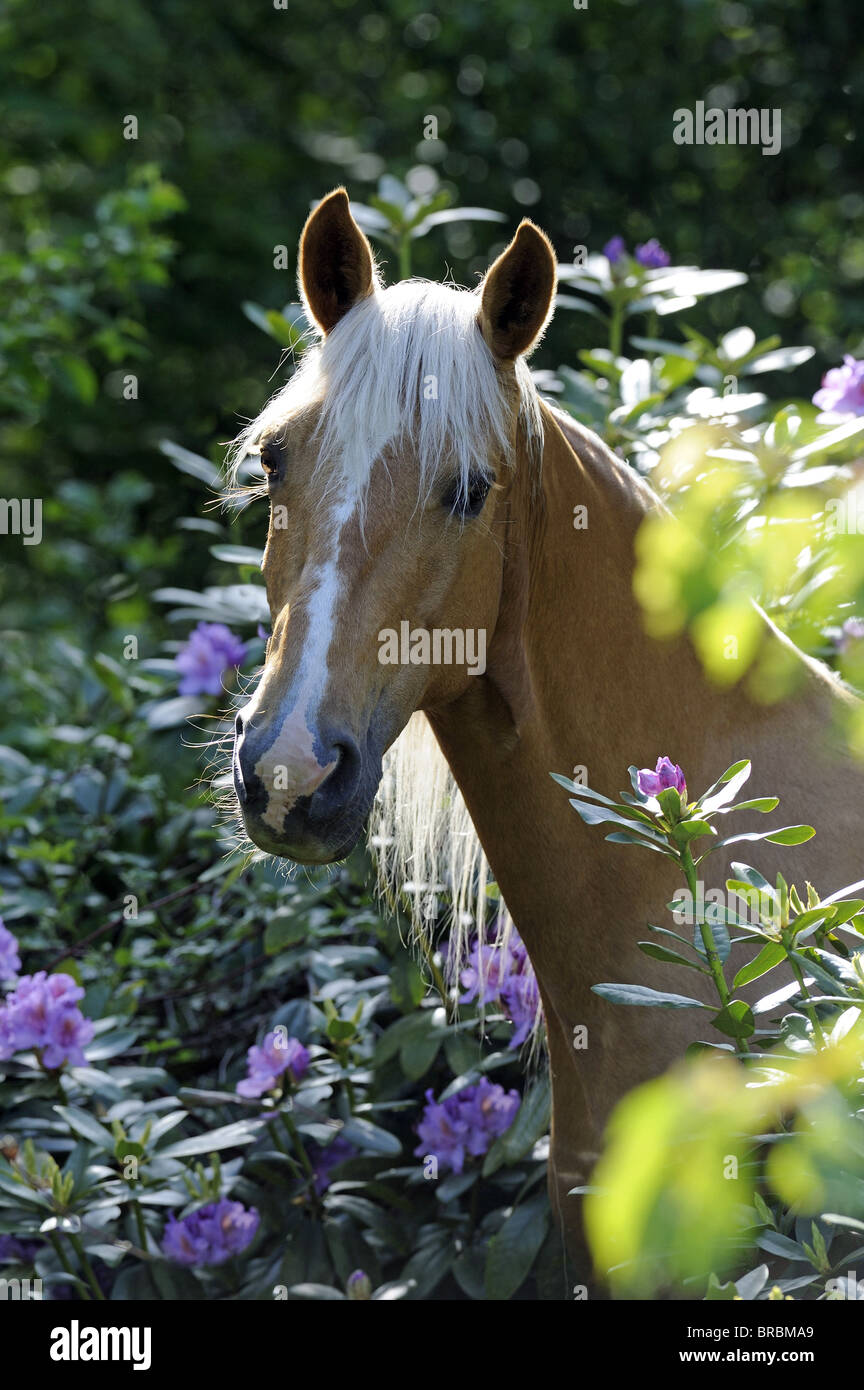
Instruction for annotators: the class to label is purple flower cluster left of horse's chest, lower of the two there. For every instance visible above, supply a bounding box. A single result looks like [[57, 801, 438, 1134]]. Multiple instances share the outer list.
[[414, 1076, 521, 1173]]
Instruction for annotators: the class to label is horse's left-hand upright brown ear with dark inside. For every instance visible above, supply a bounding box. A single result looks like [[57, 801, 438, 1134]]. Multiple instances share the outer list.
[[299, 188, 376, 334]]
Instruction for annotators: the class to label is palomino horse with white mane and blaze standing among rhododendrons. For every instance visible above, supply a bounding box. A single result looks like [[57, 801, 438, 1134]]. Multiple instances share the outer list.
[[232, 189, 864, 1265]]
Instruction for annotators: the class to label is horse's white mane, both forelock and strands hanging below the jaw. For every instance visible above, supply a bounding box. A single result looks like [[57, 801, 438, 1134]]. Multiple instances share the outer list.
[[229, 279, 543, 1028]]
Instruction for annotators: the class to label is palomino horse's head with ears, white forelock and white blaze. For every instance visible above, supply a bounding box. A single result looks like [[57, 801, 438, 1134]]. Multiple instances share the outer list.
[[233, 189, 556, 863]]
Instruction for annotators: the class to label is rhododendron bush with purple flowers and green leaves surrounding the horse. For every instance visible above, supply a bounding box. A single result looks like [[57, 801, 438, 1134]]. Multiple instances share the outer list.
[[0, 179, 864, 1301]]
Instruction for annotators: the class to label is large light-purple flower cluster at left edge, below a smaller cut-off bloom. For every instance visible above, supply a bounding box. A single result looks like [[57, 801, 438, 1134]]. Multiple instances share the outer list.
[[0, 970, 93, 1072]]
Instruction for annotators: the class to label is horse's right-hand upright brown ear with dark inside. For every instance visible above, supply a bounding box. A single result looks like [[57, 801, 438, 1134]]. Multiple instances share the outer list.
[[479, 218, 557, 361]]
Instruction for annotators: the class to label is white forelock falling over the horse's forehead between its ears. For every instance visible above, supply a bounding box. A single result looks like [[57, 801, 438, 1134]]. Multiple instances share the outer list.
[[228, 279, 543, 502]]
